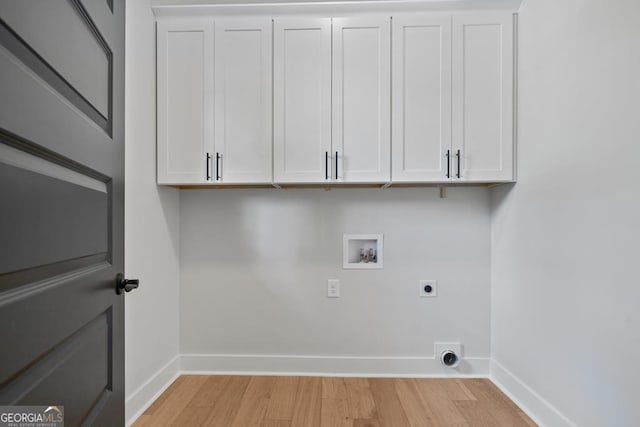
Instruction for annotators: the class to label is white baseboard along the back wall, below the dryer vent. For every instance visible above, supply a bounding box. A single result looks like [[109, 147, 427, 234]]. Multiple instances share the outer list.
[[180, 354, 490, 378]]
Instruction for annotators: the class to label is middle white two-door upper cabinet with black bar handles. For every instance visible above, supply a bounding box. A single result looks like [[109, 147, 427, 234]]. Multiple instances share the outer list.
[[274, 17, 391, 183]]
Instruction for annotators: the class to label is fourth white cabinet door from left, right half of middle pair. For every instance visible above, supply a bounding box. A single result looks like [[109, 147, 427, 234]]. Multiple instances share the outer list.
[[332, 17, 391, 182]]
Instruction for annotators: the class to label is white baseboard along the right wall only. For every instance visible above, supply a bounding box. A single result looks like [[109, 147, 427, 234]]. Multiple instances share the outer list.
[[489, 359, 576, 427]]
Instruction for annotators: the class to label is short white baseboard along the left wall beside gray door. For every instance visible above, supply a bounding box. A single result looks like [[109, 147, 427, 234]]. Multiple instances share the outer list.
[[124, 355, 180, 426]]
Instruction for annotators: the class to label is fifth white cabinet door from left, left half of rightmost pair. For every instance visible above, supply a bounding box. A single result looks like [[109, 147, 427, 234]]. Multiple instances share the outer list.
[[391, 14, 451, 182]]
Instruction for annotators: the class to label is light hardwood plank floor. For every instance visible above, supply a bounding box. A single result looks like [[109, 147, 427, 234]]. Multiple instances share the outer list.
[[134, 375, 536, 427]]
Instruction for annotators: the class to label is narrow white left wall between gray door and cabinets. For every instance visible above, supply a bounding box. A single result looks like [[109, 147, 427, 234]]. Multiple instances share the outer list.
[[125, 0, 179, 419]]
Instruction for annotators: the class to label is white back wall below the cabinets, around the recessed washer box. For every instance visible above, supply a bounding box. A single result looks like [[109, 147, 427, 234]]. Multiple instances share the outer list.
[[180, 188, 490, 374]]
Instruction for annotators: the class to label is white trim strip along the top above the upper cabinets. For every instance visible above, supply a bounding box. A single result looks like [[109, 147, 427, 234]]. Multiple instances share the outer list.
[[152, 0, 522, 19]]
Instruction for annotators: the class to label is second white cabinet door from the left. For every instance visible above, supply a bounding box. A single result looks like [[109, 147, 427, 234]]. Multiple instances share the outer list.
[[213, 19, 272, 183]]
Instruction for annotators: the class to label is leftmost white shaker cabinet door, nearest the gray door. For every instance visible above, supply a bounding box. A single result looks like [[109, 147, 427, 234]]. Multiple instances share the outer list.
[[157, 20, 213, 184]]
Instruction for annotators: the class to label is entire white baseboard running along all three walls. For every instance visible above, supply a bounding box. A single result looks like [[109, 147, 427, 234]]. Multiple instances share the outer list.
[[125, 354, 576, 427]]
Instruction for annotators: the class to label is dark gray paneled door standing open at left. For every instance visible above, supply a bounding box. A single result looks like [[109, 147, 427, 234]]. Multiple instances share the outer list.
[[0, 0, 125, 426]]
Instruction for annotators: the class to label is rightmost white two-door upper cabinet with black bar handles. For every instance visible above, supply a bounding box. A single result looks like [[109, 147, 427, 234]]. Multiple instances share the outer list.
[[392, 12, 514, 182]]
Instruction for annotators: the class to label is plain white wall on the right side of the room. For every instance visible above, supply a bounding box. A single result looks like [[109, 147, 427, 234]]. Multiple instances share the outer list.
[[492, 0, 640, 426]]
